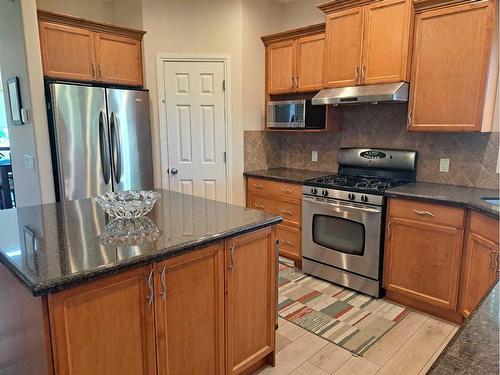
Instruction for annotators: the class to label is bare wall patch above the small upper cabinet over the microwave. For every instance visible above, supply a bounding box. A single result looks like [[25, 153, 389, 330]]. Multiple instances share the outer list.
[[283, 0, 325, 30]]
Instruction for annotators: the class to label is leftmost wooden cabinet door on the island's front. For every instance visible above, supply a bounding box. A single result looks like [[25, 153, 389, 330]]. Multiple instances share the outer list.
[[48, 267, 156, 375]]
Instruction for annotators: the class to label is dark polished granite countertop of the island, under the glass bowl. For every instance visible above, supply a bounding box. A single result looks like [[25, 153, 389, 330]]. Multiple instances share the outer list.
[[0, 190, 282, 296]]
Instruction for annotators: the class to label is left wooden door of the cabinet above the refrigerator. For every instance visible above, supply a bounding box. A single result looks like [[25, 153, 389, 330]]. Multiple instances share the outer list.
[[38, 22, 95, 81]]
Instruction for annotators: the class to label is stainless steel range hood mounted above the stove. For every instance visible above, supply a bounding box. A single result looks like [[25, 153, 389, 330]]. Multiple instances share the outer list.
[[312, 82, 409, 105]]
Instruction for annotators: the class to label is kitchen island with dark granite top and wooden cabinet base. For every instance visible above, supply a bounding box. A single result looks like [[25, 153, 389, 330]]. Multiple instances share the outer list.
[[0, 190, 282, 374]]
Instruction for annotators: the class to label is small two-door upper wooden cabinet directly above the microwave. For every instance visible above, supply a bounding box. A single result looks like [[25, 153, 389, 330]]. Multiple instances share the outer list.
[[262, 24, 325, 95]]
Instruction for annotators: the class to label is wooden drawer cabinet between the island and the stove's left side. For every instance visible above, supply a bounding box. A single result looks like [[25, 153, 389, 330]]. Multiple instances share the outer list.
[[247, 177, 302, 268]]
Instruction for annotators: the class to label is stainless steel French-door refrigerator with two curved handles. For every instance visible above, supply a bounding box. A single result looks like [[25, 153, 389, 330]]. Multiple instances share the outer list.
[[48, 83, 153, 201]]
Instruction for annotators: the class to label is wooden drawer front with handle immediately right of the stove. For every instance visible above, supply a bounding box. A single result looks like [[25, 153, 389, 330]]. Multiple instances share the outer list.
[[389, 198, 465, 228]]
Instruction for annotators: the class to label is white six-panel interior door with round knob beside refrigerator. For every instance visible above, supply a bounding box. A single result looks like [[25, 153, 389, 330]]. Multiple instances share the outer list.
[[163, 61, 227, 202]]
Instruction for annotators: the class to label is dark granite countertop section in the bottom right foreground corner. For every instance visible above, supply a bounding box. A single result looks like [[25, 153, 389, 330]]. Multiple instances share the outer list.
[[427, 282, 500, 375]]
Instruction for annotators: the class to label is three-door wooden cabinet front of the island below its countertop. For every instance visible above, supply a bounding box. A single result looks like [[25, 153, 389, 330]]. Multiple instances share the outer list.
[[47, 228, 277, 375]]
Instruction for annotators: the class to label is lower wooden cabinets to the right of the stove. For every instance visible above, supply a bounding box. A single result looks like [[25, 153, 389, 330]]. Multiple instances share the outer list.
[[383, 198, 500, 323]]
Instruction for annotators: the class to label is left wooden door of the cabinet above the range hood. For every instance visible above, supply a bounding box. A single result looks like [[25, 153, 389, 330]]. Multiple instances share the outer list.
[[324, 7, 363, 87]]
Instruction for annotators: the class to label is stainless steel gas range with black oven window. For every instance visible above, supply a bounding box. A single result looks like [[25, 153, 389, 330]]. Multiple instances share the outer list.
[[302, 148, 417, 297]]
